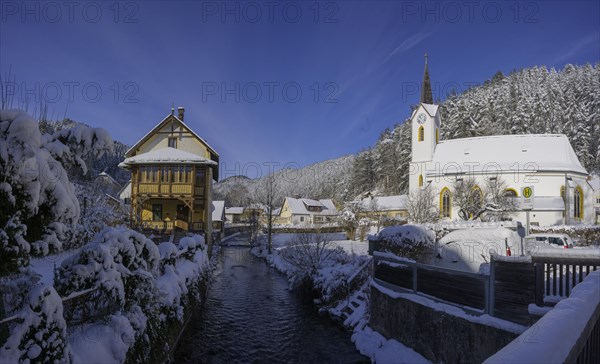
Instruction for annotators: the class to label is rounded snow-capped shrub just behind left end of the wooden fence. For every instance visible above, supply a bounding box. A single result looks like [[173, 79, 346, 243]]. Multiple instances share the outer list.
[[369, 225, 435, 262]]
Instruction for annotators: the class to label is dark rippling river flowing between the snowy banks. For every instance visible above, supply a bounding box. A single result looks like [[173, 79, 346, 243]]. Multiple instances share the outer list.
[[174, 240, 368, 363]]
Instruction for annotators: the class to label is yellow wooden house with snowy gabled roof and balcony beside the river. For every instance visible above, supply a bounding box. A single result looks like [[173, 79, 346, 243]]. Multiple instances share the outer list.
[[119, 107, 219, 242]]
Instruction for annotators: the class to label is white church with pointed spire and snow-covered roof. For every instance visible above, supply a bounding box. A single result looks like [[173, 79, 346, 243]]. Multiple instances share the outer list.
[[409, 56, 594, 226]]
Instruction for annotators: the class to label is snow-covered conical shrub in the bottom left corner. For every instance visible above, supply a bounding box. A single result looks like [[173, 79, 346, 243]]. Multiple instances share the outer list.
[[0, 286, 70, 363]]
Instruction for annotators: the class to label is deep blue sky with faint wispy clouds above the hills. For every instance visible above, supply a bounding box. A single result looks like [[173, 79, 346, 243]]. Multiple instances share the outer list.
[[0, 1, 600, 177]]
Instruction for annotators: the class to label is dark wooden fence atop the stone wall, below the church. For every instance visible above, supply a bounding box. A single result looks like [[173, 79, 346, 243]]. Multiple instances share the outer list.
[[373, 251, 600, 325]]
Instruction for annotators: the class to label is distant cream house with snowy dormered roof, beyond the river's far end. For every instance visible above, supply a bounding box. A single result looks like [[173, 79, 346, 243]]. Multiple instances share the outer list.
[[275, 197, 339, 225]]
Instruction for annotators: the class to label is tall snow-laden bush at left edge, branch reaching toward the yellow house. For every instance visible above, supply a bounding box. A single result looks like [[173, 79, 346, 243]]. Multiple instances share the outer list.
[[0, 110, 112, 274]]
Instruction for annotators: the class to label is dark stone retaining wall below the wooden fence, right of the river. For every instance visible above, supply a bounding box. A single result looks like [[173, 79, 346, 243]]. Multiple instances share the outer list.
[[370, 285, 518, 363]]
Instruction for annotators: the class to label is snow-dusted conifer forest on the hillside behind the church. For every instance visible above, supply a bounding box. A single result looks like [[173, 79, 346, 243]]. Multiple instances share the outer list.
[[286, 64, 600, 205]]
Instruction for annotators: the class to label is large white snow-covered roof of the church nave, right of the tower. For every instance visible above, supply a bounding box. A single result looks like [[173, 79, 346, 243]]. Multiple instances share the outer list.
[[431, 134, 587, 175]]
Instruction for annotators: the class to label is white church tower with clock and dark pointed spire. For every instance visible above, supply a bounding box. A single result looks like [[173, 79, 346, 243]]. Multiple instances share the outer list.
[[409, 54, 441, 191]]
